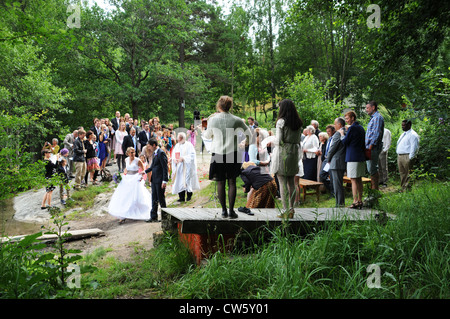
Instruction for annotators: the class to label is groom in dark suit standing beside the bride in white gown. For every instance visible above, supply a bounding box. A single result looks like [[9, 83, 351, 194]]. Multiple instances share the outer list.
[[145, 138, 169, 222]]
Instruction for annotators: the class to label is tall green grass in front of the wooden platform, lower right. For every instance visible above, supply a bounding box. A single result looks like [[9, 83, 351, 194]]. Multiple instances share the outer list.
[[167, 183, 450, 298]]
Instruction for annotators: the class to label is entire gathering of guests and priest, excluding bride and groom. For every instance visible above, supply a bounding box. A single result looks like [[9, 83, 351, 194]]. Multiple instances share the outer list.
[[41, 100, 419, 218]]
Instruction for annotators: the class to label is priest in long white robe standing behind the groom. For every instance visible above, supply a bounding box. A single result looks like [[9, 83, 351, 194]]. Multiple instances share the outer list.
[[172, 132, 200, 202]]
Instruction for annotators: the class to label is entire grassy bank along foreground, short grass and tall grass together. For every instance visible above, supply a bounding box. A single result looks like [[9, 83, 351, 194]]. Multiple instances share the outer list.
[[76, 183, 450, 299]]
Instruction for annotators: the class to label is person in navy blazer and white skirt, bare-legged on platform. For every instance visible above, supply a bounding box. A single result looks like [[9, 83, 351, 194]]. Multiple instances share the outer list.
[[340, 111, 366, 209]]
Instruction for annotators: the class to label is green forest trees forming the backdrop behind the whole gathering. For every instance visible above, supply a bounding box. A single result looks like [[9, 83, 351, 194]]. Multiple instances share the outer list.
[[0, 0, 450, 198]]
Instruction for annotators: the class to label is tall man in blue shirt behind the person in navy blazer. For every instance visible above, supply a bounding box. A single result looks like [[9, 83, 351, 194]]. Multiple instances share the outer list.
[[366, 101, 384, 189]]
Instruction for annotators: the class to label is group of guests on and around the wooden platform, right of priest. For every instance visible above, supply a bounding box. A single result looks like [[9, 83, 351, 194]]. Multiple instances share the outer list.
[[206, 97, 419, 218]]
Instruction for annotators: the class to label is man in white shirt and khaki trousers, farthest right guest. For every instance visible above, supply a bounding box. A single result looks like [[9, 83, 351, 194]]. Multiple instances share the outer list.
[[396, 120, 420, 190]]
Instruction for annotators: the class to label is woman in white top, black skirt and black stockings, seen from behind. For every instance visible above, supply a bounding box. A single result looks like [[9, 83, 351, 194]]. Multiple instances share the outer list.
[[202, 96, 251, 218]]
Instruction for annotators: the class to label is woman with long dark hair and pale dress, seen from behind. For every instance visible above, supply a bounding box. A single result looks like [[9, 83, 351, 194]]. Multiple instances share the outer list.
[[270, 99, 303, 218]]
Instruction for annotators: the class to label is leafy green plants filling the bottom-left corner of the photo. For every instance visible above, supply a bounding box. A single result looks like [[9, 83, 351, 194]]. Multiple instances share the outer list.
[[0, 208, 81, 299]]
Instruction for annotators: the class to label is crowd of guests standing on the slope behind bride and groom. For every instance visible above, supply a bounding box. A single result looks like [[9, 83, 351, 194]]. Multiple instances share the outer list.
[[41, 111, 192, 209]]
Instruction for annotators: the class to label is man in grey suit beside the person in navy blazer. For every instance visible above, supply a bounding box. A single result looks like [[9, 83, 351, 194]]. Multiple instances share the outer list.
[[327, 117, 347, 207]]
